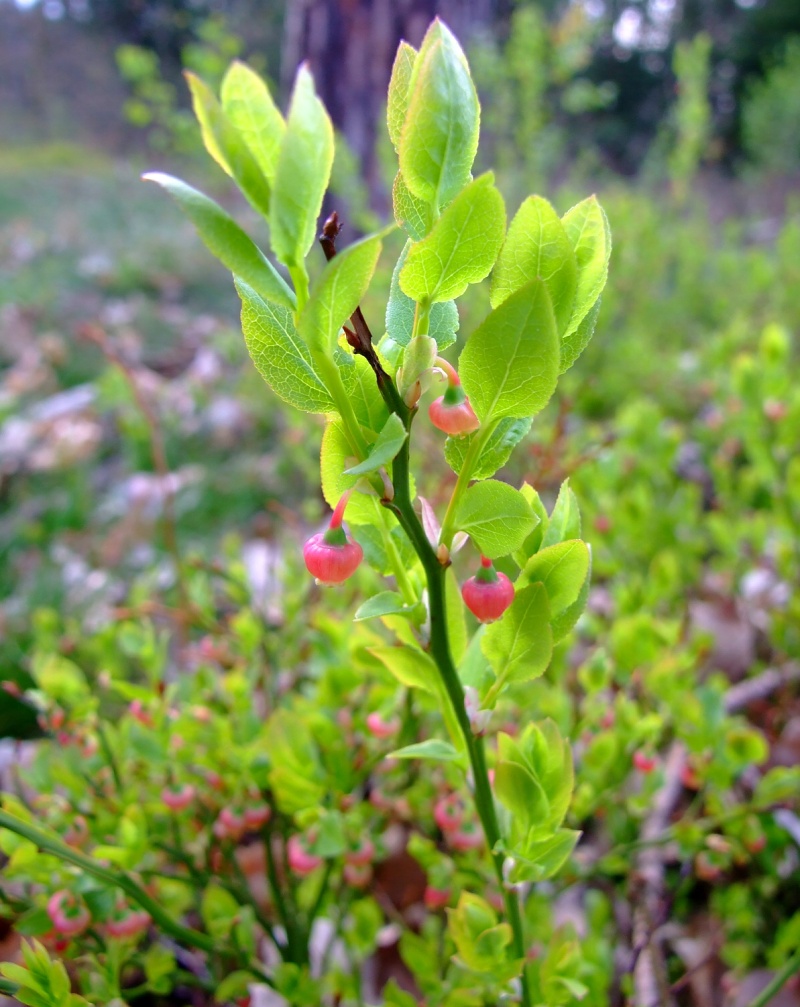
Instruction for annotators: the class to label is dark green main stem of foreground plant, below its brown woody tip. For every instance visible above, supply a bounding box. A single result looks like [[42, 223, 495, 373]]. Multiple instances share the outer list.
[[386, 435, 531, 1007]]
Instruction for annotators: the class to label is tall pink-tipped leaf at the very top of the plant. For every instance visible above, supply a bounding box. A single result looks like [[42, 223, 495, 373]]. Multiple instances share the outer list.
[[398, 18, 481, 208]]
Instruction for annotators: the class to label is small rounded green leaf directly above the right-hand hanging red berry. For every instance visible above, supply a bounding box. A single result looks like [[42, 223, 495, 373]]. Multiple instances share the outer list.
[[454, 479, 535, 560]]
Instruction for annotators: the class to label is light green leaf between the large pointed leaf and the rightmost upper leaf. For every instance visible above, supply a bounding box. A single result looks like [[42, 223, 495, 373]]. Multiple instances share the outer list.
[[490, 195, 577, 332]]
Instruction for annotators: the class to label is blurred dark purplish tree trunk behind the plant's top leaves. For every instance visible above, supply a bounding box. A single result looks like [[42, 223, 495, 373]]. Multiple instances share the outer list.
[[281, 0, 499, 209]]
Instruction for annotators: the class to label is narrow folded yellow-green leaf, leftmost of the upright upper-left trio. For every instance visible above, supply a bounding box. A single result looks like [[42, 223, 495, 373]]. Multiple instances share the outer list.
[[184, 70, 270, 218]]
